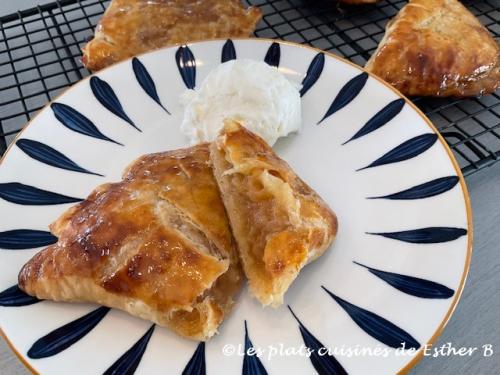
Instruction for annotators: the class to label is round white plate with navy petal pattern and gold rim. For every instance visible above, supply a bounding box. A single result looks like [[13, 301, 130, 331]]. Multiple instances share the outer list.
[[0, 39, 472, 374]]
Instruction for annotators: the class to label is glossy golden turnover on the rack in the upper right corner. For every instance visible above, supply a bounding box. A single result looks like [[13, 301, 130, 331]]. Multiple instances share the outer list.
[[366, 0, 500, 97]]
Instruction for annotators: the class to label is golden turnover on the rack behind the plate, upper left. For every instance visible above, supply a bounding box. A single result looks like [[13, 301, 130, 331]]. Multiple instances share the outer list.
[[82, 0, 262, 71]]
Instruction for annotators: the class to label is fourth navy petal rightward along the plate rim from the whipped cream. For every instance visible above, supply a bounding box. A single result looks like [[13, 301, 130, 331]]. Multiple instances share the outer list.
[[358, 133, 438, 171]]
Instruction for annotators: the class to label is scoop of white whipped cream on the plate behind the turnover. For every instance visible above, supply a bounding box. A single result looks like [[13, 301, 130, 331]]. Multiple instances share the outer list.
[[181, 59, 302, 146]]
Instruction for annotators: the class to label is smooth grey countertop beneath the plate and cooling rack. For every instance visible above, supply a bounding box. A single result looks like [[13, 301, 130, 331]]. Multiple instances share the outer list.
[[0, 0, 500, 375]]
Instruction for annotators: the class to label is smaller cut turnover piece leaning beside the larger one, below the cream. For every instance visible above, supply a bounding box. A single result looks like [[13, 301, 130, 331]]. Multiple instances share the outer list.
[[210, 121, 337, 307]]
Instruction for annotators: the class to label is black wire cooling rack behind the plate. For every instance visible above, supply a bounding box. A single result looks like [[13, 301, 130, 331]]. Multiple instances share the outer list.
[[0, 0, 500, 175]]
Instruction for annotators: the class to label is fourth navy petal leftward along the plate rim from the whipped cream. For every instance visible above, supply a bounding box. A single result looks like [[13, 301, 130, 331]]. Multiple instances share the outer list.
[[50, 103, 123, 146]]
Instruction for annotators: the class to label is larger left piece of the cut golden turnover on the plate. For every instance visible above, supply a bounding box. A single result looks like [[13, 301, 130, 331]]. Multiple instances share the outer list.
[[19, 144, 243, 340]]
